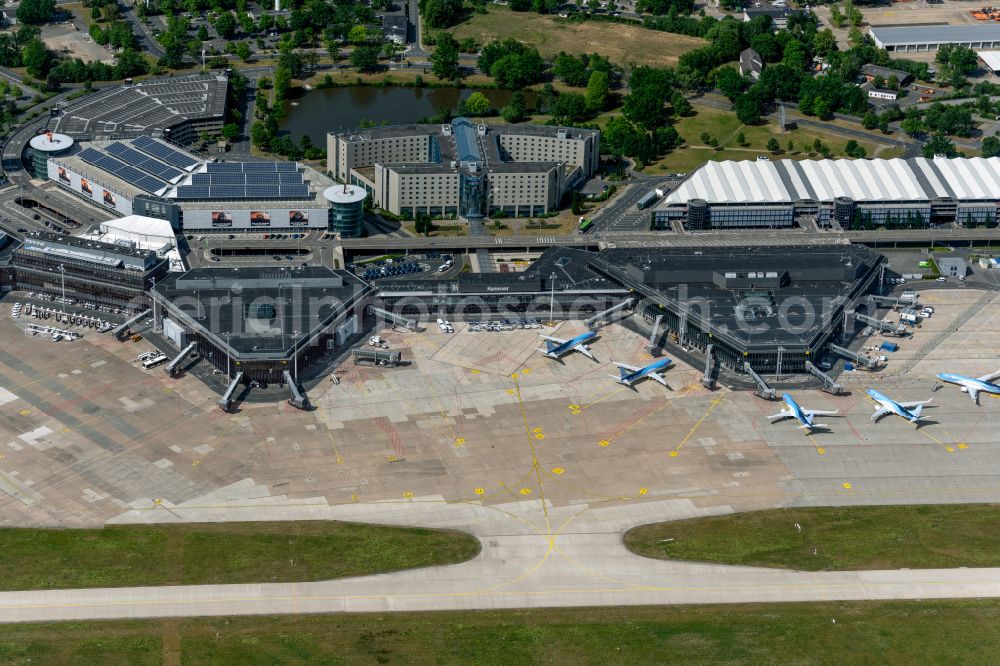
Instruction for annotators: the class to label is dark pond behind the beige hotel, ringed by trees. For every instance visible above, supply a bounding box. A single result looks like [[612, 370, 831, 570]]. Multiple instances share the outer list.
[[279, 86, 534, 146]]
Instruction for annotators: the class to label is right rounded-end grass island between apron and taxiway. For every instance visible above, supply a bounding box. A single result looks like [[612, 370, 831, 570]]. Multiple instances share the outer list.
[[625, 504, 1000, 571]]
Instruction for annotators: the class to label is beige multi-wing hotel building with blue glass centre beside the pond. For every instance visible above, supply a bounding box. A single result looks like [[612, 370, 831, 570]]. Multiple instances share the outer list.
[[327, 118, 600, 219]]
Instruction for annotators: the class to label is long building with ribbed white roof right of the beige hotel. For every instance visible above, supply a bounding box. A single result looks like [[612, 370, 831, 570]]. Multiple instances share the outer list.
[[652, 157, 1000, 230]]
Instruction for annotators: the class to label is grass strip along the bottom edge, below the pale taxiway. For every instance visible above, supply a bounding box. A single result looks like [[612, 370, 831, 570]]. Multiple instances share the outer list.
[[0, 600, 1000, 666]]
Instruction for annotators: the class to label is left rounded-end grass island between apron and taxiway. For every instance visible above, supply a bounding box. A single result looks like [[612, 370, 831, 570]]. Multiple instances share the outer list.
[[0, 521, 479, 588]]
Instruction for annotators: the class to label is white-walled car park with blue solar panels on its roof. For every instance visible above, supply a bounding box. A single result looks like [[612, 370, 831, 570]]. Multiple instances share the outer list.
[[46, 136, 363, 236]]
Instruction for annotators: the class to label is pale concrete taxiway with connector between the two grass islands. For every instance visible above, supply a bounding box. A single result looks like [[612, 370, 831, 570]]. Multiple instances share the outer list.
[[0, 498, 1000, 622]]
